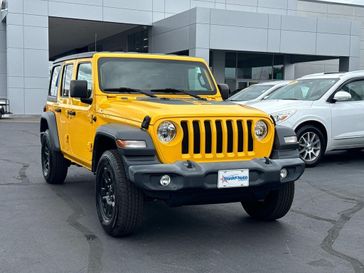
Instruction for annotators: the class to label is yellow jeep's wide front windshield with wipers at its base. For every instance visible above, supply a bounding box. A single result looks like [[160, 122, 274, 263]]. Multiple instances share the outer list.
[[99, 58, 216, 94]]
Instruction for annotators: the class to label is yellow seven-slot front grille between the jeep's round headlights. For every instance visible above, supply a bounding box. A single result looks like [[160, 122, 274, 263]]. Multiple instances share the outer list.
[[181, 118, 254, 159]]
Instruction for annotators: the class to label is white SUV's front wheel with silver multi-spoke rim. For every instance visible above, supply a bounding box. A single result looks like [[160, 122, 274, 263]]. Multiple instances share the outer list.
[[297, 125, 326, 167]]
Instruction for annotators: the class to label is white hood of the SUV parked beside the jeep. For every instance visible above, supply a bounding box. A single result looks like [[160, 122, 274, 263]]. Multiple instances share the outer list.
[[249, 100, 313, 114]]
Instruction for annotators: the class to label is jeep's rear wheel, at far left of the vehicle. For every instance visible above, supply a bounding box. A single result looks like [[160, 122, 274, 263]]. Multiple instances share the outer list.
[[41, 130, 69, 184]]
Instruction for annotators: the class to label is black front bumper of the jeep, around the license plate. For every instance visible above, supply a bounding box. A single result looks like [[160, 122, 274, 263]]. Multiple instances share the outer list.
[[128, 158, 305, 192]]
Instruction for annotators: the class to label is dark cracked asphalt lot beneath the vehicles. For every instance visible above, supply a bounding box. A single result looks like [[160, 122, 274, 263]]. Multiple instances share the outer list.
[[0, 118, 364, 273]]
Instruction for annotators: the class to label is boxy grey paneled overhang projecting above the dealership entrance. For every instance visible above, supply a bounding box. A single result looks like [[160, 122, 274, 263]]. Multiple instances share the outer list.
[[150, 8, 360, 58]]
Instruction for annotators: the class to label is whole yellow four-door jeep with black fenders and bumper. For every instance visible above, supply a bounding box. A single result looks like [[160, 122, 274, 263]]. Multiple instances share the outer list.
[[40, 52, 304, 236]]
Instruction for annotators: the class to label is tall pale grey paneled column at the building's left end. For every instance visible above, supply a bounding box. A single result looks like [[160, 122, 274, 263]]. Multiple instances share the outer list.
[[6, 0, 49, 114]]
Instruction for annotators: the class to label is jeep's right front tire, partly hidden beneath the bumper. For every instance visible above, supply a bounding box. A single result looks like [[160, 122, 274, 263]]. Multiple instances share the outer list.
[[241, 182, 295, 221]]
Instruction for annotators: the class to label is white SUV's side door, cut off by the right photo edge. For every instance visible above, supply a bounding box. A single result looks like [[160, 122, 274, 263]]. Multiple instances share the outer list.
[[331, 78, 364, 148]]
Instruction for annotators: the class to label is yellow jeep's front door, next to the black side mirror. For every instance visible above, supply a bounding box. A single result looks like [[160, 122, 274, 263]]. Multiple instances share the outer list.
[[69, 60, 95, 168]]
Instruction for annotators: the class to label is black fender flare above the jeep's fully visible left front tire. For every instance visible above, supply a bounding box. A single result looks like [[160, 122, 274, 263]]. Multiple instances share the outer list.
[[92, 123, 156, 172]]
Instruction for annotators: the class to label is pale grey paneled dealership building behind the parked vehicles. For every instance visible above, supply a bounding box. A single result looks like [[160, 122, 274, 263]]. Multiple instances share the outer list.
[[0, 0, 364, 114]]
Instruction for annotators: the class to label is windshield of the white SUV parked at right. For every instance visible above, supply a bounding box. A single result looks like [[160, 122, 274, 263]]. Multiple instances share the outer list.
[[267, 79, 338, 101]]
